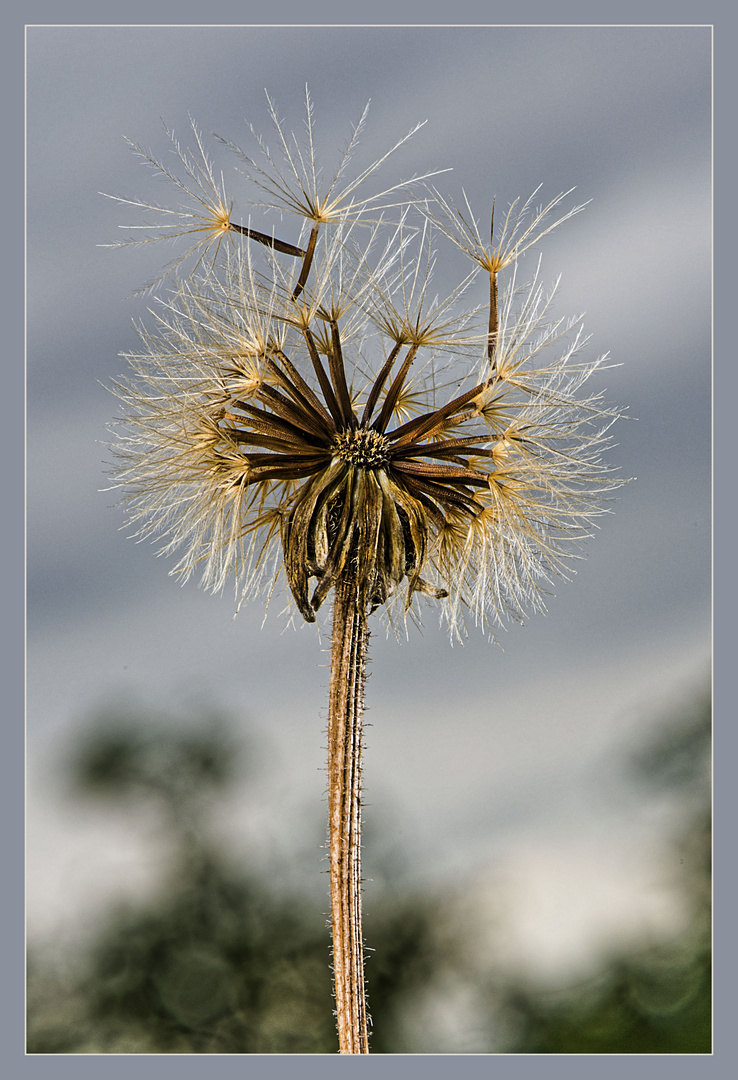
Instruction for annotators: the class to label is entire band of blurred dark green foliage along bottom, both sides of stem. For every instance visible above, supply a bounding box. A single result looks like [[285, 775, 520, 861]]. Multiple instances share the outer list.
[[28, 691, 711, 1054]]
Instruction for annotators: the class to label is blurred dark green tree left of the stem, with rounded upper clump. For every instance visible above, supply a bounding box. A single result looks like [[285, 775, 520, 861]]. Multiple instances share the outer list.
[[28, 715, 335, 1053]]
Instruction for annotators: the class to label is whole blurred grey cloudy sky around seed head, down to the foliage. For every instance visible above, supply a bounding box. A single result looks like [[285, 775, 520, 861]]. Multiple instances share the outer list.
[[27, 27, 711, 1052]]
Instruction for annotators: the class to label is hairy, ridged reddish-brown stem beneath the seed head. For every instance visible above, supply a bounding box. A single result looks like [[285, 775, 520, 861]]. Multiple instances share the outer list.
[[328, 579, 368, 1054]]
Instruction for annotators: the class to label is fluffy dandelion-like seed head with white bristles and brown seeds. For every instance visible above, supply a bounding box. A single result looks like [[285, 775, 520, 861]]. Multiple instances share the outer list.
[[108, 102, 618, 634]]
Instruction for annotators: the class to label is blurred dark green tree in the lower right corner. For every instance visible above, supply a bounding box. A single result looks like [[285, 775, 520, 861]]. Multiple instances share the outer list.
[[506, 696, 712, 1054]]
